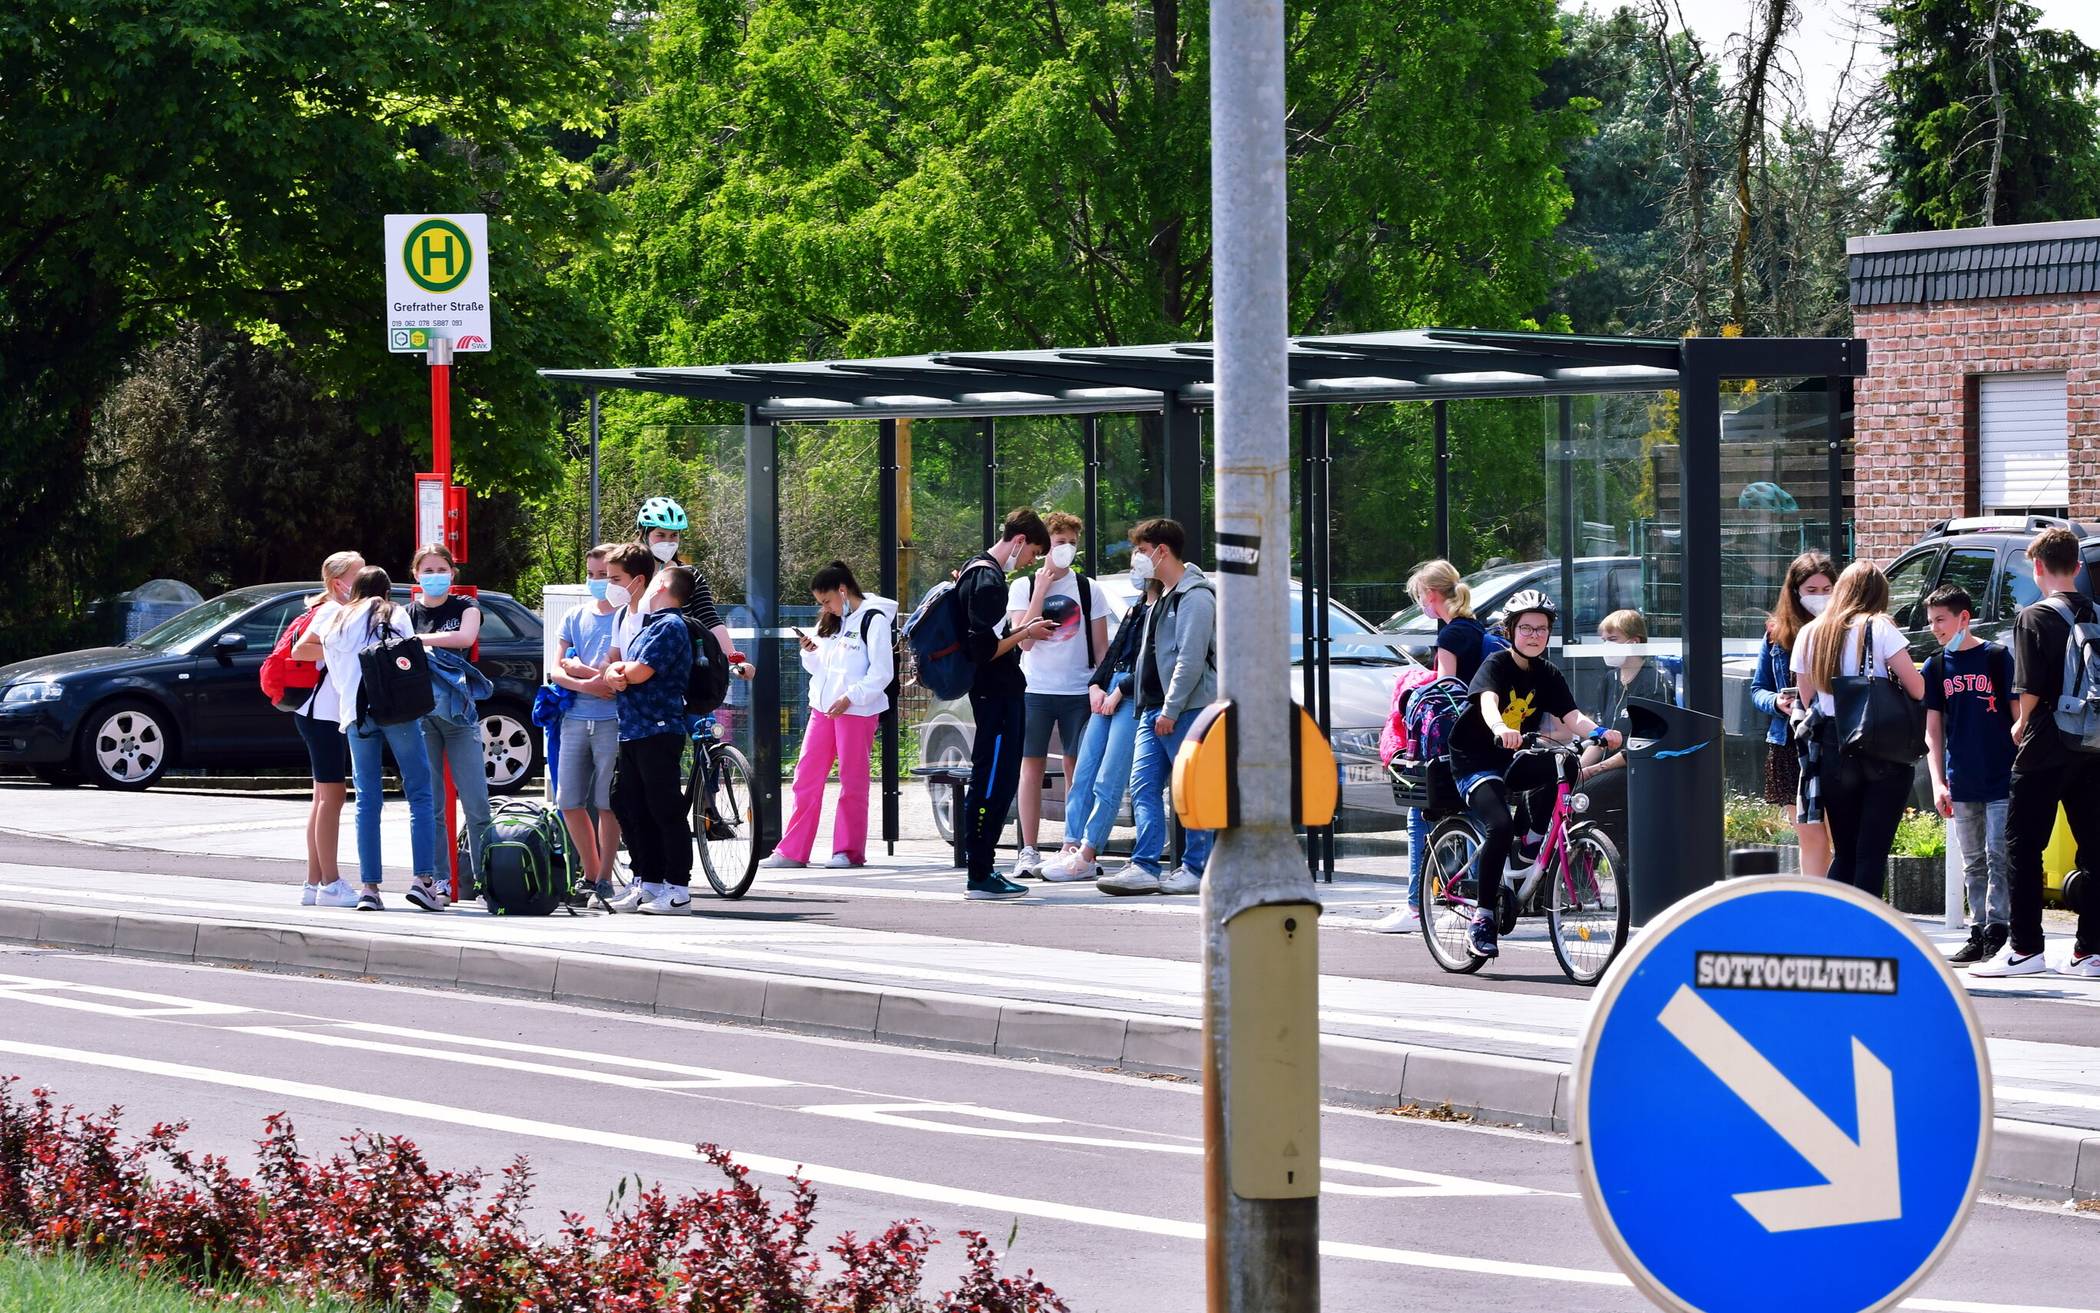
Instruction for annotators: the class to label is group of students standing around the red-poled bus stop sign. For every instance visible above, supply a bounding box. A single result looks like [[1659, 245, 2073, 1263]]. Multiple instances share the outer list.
[[290, 498, 752, 916]]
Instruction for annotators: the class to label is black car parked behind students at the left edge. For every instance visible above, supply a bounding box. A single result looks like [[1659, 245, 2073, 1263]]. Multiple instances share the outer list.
[[0, 584, 542, 792]]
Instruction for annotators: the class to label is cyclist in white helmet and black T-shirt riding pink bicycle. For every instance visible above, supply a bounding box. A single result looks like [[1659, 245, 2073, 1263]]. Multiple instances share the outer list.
[[1451, 588, 1621, 958]]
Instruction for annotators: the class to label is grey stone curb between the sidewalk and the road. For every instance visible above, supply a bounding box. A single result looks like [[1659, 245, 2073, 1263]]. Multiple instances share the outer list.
[[0, 903, 2100, 1200]]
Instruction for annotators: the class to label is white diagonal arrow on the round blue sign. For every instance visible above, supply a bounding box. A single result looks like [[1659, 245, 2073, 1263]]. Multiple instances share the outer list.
[[1659, 985, 1903, 1231]]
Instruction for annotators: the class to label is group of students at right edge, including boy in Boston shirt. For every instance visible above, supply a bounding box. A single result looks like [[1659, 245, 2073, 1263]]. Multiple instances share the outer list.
[[1751, 527, 2100, 977]]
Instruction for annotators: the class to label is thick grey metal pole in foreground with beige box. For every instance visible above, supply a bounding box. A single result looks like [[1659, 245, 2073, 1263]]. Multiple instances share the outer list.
[[1209, 0, 1319, 1313]]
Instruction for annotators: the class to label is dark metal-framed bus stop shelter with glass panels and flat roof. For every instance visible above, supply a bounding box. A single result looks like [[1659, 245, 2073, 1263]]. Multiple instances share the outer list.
[[542, 330, 1867, 874]]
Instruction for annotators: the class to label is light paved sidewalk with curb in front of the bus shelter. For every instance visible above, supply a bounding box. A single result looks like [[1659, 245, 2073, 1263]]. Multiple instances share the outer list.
[[0, 790, 2100, 1195]]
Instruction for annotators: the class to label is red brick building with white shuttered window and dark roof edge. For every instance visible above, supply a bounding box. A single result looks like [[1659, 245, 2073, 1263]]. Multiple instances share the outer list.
[[1846, 218, 2100, 561]]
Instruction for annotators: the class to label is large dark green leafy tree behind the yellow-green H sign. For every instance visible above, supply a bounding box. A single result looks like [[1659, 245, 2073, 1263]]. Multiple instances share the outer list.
[[0, 0, 617, 628]]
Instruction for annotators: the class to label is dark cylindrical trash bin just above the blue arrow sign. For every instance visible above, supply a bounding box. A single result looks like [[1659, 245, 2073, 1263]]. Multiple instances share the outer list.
[[1621, 697, 1726, 926]]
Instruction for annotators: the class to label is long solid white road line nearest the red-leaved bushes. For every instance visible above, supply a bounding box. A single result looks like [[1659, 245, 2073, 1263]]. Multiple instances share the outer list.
[[0, 1040, 2096, 1313]]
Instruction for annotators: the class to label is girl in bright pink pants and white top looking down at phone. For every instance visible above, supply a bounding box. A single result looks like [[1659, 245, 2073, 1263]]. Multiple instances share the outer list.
[[758, 561, 897, 870]]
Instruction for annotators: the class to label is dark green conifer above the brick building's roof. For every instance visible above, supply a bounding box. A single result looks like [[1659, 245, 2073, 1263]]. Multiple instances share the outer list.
[[1880, 0, 2100, 231]]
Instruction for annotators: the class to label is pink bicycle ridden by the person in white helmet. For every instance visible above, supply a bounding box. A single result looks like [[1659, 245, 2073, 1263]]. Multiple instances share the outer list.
[[1420, 733, 1628, 985]]
